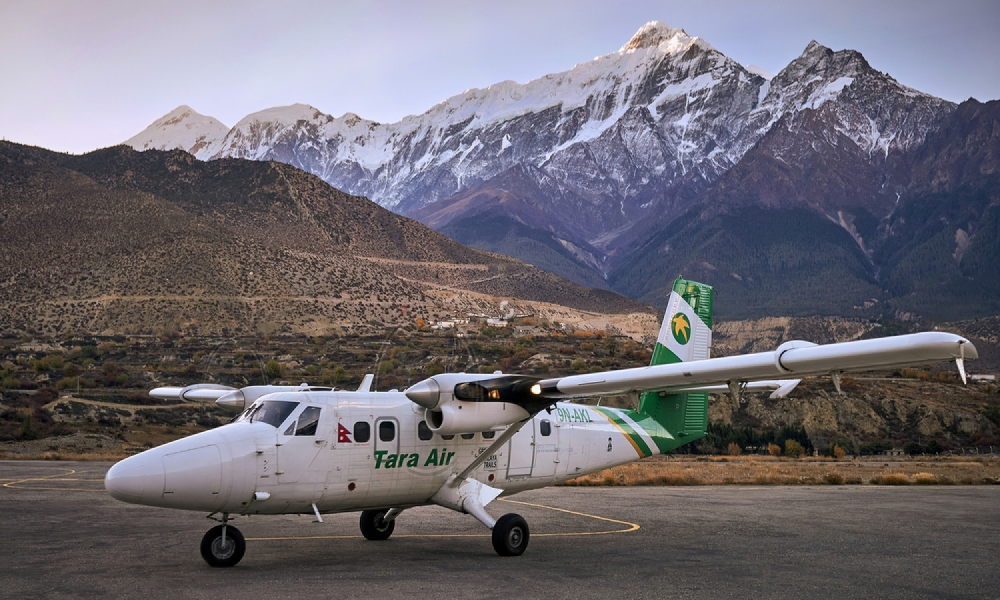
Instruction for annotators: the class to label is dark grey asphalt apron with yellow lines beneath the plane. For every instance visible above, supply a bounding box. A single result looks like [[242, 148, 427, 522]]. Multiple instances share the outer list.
[[0, 461, 1000, 600]]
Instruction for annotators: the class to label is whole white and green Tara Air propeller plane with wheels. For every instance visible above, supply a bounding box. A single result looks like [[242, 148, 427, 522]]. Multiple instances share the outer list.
[[104, 278, 978, 567]]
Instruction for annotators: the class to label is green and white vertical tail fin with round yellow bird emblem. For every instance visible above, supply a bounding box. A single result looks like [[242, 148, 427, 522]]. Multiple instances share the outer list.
[[639, 278, 714, 452]]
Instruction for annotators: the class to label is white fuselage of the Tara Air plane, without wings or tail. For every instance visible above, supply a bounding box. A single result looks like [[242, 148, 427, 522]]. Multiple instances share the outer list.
[[107, 391, 642, 514]]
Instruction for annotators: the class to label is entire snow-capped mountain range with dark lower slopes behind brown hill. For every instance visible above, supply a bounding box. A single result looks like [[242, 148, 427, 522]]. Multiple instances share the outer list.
[[128, 22, 984, 322]]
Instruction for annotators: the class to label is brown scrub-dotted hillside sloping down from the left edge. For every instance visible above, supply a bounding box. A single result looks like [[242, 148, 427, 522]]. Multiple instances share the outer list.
[[0, 142, 649, 335]]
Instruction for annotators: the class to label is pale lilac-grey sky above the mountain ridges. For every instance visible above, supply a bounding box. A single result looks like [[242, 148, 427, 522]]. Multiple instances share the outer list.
[[0, 0, 1000, 152]]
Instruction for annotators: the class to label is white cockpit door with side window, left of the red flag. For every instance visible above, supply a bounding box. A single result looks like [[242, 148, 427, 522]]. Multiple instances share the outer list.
[[277, 403, 332, 483]]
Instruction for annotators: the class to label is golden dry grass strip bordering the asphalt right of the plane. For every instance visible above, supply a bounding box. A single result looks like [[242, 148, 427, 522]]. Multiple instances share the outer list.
[[565, 457, 1000, 486]]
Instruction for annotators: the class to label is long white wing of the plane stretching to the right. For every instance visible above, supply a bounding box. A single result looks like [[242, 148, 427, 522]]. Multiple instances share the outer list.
[[539, 331, 978, 399]]
